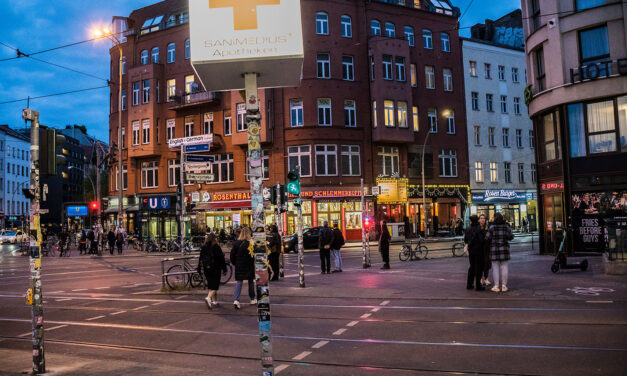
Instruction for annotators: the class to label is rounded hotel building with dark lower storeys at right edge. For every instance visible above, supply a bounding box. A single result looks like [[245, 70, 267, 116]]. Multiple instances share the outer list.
[[522, 0, 627, 253]]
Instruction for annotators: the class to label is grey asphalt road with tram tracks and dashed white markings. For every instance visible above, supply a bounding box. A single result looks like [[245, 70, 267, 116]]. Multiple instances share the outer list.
[[0, 238, 627, 375]]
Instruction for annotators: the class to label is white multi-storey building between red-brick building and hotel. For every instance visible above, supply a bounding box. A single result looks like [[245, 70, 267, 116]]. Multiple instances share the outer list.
[[462, 39, 537, 229]]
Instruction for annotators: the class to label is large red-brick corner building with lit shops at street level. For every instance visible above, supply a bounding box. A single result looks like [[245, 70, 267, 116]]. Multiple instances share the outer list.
[[109, 0, 470, 239]]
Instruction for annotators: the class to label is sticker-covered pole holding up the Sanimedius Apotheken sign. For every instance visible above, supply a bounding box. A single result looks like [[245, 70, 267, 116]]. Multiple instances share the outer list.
[[244, 73, 278, 376]]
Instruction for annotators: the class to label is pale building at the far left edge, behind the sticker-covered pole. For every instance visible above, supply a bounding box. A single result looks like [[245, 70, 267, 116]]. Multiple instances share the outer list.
[[0, 124, 30, 228]]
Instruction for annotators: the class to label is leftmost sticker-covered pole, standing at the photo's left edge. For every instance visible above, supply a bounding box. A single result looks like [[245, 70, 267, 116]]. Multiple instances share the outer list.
[[22, 109, 44, 374]]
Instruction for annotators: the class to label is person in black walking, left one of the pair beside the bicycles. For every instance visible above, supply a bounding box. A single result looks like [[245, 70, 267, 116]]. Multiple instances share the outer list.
[[198, 234, 226, 309]]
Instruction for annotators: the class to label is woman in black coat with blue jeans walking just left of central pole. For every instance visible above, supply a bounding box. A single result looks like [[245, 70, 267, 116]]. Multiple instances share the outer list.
[[231, 227, 257, 309]]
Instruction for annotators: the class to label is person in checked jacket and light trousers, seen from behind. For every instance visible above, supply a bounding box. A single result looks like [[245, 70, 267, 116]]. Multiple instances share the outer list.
[[486, 213, 514, 292]]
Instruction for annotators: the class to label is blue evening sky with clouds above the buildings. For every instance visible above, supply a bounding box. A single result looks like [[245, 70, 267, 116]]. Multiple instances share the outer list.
[[0, 0, 520, 142]]
